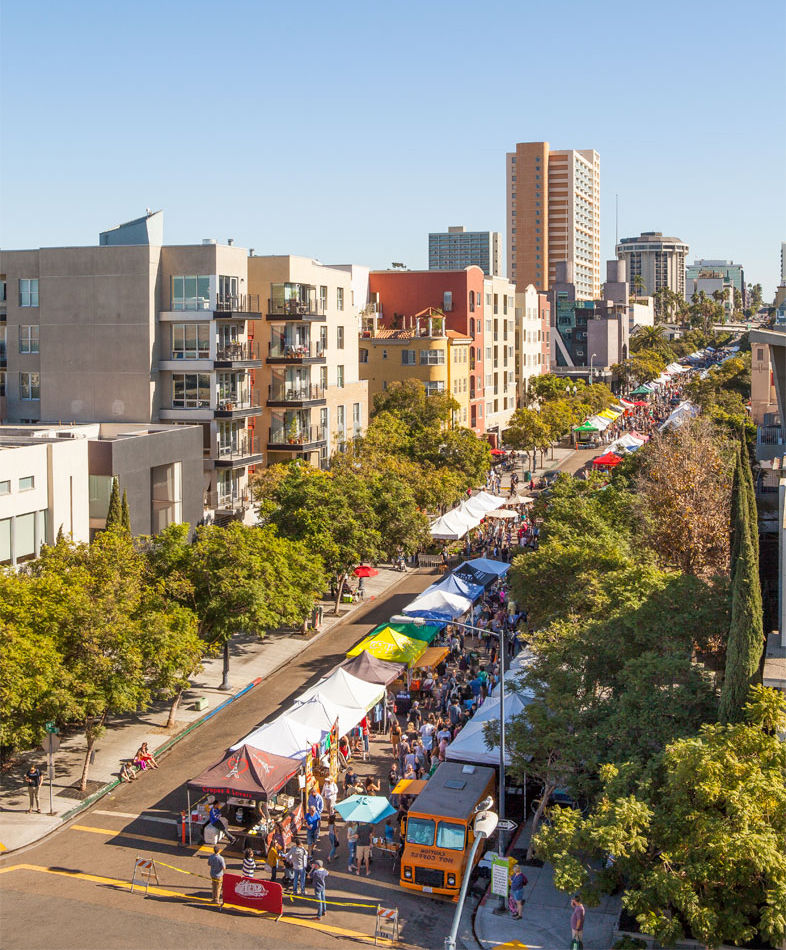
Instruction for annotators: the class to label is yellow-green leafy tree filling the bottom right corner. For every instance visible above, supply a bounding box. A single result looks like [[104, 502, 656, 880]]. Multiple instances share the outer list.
[[536, 686, 786, 948]]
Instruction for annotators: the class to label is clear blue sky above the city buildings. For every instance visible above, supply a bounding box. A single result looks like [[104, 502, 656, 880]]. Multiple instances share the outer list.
[[0, 0, 786, 295]]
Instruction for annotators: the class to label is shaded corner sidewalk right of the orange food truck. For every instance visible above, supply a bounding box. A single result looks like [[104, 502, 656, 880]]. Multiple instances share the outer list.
[[465, 820, 622, 950]]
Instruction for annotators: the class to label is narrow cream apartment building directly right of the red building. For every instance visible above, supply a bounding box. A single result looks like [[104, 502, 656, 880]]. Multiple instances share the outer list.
[[483, 277, 518, 443]]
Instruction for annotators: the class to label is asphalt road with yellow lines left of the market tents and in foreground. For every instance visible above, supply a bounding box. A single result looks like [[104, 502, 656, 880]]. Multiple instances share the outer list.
[[0, 572, 453, 950]]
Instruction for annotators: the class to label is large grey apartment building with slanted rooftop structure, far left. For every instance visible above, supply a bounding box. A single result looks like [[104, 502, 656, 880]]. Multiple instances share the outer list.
[[0, 212, 264, 518]]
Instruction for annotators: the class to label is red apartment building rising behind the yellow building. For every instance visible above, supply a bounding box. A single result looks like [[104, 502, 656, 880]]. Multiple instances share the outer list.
[[369, 265, 486, 435]]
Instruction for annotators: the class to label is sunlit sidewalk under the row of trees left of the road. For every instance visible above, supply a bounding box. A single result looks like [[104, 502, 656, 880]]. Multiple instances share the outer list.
[[0, 567, 411, 852]]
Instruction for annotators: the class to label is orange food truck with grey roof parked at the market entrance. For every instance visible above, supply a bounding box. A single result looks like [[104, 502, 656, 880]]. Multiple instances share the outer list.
[[399, 762, 496, 900]]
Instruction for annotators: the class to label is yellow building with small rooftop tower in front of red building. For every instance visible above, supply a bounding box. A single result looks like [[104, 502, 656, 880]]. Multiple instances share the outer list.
[[359, 308, 472, 425]]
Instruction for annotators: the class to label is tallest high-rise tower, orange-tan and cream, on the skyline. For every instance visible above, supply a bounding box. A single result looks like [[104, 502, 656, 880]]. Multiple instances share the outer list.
[[506, 142, 600, 299]]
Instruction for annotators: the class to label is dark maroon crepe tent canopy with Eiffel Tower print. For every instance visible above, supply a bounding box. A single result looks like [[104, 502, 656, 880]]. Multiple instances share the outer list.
[[188, 745, 300, 801]]
